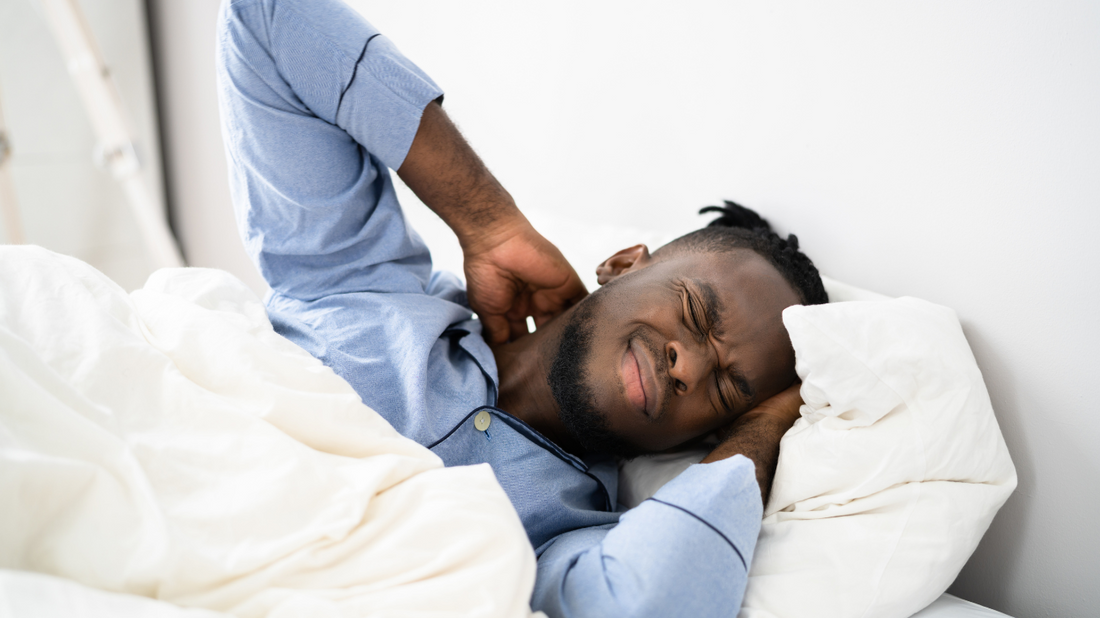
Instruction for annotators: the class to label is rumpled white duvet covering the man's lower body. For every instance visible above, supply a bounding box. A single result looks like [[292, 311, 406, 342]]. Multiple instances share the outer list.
[[0, 247, 535, 617]]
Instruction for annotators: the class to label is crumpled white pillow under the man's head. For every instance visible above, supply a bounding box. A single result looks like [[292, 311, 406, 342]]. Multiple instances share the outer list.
[[620, 282, 1016, 618]]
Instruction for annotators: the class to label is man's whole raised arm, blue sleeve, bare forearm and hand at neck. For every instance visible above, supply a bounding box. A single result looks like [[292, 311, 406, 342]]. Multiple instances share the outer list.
[[218, 0, 586, 341]]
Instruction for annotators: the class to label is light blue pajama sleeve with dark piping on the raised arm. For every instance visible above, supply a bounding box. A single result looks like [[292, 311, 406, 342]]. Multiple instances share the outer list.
[[217, 0, 442, 300]]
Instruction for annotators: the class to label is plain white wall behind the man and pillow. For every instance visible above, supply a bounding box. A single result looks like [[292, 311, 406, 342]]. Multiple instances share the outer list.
[[151, 0, 1100, 617]]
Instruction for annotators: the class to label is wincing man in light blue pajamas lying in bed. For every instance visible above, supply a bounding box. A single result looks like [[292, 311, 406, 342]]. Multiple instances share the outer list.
[[218, 0, 825, 616]]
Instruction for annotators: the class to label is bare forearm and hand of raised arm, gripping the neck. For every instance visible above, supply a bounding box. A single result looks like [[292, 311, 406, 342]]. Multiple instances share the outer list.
[[397, 102, 587, 343]]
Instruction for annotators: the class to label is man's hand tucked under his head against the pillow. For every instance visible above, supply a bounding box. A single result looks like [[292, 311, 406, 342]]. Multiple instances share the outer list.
[[703, 382, 802, 507]]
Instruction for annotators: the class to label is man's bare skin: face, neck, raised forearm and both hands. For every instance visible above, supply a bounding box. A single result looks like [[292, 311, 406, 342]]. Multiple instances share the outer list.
[[397, 103, 801, 498]]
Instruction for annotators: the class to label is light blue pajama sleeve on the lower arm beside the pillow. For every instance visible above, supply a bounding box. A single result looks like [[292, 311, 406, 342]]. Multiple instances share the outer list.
[[531, 455, 763, 618]]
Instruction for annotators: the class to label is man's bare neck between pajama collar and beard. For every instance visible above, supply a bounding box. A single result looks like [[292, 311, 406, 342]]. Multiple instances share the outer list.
[[492, 311, 576, 452]]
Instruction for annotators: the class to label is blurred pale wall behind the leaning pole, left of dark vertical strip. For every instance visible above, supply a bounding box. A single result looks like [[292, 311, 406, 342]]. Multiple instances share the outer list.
[[0, 0, 162, 289]]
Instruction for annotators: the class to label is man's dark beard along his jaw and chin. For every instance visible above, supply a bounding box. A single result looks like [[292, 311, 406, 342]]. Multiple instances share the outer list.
[[547, 290, 644, 460]]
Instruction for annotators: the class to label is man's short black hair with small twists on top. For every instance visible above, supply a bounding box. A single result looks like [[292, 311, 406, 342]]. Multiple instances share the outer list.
[[655, 200, 828, 305]]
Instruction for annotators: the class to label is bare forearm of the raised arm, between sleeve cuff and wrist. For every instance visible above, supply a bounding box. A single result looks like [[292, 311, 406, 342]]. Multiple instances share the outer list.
[[397, 102, 526, 250]]
